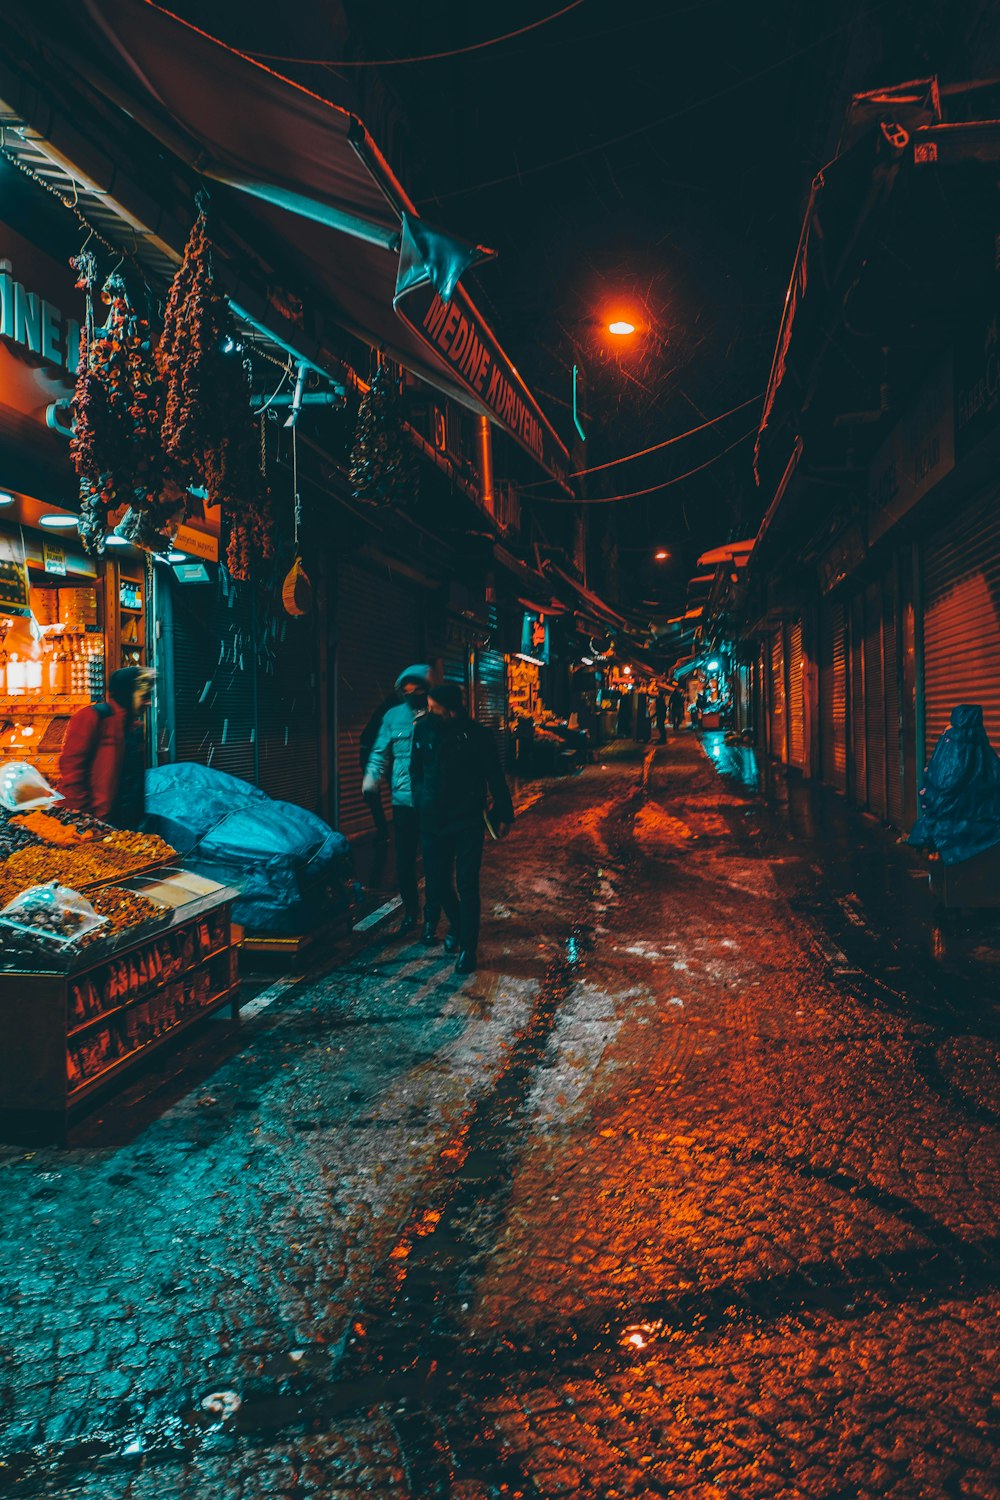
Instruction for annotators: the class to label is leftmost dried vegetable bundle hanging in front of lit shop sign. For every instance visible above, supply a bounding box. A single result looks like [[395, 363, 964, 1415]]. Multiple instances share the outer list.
[[70, 254, 162, 554]]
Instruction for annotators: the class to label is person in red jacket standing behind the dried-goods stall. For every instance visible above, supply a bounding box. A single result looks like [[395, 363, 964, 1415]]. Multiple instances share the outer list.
[[58, 666, 156, 830]]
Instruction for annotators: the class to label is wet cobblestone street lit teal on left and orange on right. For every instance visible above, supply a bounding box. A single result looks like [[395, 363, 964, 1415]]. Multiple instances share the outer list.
[[0, 737, 1000, 1500]]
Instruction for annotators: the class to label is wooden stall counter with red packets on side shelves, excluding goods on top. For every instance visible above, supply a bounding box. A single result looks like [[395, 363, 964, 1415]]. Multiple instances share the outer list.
[[0, 869, 240, 1143]]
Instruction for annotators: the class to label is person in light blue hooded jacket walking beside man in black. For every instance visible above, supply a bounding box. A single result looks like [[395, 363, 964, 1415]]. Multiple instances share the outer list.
[[361, 663, 430, 938]]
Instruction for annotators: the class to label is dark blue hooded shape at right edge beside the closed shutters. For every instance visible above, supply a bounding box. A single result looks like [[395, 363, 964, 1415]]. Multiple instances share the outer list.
[[909, 704, 1000, 864]]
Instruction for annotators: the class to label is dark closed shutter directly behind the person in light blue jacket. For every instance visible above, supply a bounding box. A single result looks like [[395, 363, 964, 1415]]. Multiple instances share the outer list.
[[336, 564, 426, 839]]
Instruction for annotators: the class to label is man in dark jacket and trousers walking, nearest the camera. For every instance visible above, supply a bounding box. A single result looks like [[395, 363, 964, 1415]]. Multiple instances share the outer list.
[[411, 683, 514, 974]]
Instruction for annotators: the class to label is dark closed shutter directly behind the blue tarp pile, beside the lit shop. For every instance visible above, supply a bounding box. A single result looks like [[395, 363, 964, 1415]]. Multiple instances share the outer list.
[[171, 569, 256, 782]]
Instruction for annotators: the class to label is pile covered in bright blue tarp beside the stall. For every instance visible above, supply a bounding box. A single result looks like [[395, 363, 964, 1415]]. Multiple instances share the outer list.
[[145, 764, 351, 933]]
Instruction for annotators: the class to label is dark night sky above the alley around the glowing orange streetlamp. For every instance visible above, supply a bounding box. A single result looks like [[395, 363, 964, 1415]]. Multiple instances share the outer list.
[[173, 0, 985, 609]]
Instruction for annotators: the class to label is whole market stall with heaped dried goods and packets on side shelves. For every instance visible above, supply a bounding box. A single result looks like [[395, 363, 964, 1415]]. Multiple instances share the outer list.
[[0, 764, 238, 1142]]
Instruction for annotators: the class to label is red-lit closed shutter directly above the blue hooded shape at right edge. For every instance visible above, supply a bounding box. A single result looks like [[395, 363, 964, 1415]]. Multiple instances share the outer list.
[[924, 494, 1000, 756]]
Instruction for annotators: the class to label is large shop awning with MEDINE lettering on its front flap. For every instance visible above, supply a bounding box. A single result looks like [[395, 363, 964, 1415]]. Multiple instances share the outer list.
[[12, 0, 568, 488]]
